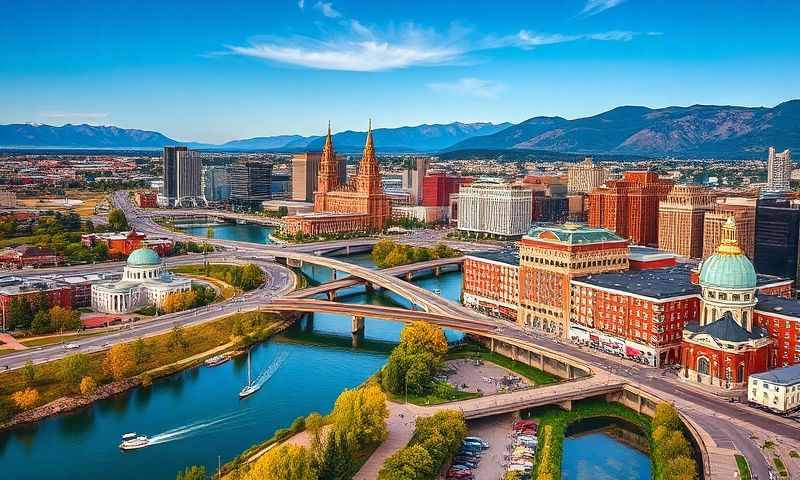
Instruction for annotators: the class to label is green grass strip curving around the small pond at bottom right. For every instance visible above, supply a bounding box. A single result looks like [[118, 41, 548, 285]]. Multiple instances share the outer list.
[[522, 400, 660, 479]]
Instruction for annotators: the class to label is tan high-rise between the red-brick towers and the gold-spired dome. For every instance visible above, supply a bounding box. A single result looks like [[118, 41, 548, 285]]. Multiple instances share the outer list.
[[658, 185, 714, 258]]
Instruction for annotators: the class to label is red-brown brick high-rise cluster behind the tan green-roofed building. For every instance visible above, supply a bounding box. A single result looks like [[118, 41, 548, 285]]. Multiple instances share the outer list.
[[589, 171, 672, 246]]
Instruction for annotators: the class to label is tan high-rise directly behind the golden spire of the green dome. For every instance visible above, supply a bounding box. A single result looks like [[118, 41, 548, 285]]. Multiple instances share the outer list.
[[703, 197, 756, 259]]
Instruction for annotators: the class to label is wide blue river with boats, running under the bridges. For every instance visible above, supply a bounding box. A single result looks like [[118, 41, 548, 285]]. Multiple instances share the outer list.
[[0, 246, 461, 480]]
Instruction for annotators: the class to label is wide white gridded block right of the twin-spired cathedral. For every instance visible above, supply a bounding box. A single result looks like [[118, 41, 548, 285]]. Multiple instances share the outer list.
[[458, 183, 533, 237]]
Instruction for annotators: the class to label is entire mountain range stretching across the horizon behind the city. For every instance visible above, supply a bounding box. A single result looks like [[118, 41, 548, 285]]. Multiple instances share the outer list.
[[0, 100, 800, 158]]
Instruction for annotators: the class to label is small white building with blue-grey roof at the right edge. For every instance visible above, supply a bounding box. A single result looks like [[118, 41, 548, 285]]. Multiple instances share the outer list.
[[747, 364, 800, 412]]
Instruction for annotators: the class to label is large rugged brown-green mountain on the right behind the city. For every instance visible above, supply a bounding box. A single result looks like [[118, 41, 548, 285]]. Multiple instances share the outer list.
[[446, 100, 800, 158]]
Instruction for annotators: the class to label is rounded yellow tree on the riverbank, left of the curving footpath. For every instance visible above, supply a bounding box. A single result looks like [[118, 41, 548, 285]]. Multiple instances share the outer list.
[[331, 385, 389, 450]]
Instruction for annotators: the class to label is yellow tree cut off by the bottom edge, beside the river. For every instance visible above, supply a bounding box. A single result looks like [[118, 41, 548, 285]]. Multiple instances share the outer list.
[[241, 444, 317, 480]]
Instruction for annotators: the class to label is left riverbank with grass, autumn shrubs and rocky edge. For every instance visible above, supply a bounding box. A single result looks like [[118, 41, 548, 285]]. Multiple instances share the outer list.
[[0, 312, 293, 430]]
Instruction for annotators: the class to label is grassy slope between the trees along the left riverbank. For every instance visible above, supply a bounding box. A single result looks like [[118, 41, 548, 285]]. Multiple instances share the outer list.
[[0, 312, 279, 421]]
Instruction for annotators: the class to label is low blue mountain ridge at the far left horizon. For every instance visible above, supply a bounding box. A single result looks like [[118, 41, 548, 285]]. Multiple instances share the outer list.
[[0, 123, 178, 148]]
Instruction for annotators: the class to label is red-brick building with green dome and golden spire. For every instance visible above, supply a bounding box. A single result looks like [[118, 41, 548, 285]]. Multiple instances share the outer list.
[[681, 218, 771, 388]]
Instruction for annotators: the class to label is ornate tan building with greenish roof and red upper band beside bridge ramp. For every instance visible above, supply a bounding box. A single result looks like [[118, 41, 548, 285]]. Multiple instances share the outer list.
[[517, 224, 628, 336]]
